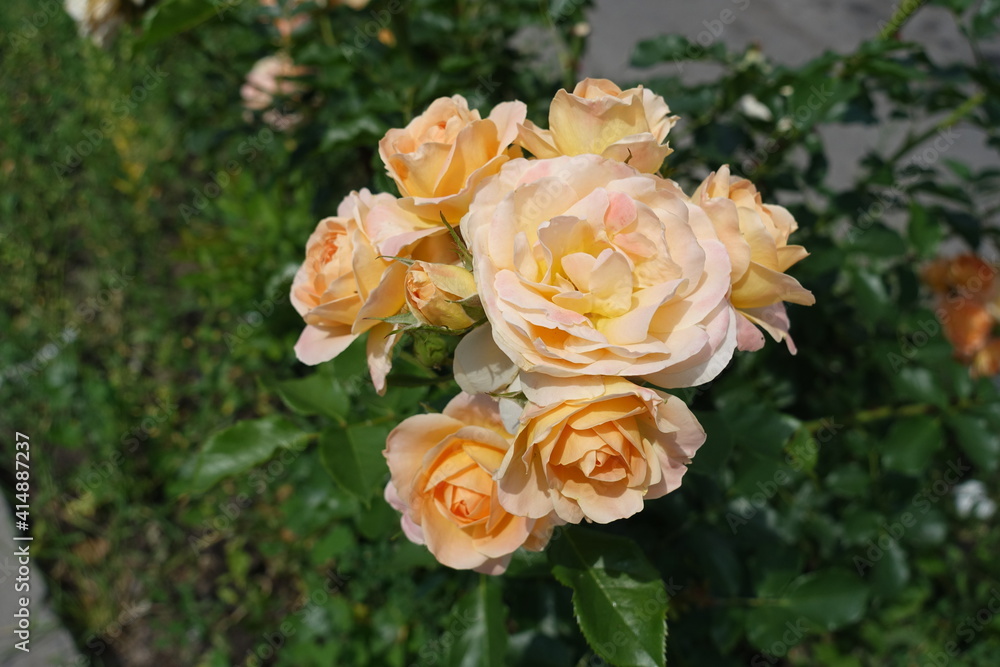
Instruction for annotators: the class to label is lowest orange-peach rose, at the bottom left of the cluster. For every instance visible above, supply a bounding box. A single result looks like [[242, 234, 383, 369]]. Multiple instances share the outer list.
[[384, 393, 556, 574]]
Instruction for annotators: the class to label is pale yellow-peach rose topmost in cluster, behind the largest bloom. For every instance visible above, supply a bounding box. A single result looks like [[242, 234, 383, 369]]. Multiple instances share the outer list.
[[517, 79, 678, 173]]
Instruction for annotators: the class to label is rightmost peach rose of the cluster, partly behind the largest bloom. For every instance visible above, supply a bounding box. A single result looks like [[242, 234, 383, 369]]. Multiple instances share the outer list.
[[691, 166, 816, 354]]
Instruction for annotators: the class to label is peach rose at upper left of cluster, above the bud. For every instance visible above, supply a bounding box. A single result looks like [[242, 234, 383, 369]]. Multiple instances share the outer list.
[[378, 95, 527, 223]]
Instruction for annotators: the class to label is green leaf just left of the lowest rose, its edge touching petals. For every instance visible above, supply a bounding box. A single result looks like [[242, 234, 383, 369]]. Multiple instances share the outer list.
[[319, 424, 389, 503]]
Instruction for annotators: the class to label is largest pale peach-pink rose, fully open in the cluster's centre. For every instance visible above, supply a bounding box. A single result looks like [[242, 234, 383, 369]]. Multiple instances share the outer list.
[[456, 155, 736, 387]]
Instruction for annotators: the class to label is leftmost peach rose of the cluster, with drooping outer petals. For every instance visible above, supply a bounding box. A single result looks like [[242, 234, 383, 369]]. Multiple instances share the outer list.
[[291, 190, 455, 393]]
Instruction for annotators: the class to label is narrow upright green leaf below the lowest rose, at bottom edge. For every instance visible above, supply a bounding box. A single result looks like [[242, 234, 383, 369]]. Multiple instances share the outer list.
[[445, 575, 507, 667]]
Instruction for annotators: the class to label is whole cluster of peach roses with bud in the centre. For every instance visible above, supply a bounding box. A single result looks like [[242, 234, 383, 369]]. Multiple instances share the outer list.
[[291, 79, 814, 573]]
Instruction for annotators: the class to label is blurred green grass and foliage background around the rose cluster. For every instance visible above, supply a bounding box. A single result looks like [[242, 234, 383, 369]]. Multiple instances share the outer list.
[[0, 0, 1000, 667]]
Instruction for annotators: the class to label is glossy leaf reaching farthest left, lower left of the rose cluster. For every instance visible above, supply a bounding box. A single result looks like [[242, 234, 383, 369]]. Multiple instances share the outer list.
[[189, 417, 309, 491]]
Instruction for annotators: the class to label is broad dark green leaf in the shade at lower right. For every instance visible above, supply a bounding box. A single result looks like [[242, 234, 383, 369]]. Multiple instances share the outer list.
[[786, 570, 868, 631]]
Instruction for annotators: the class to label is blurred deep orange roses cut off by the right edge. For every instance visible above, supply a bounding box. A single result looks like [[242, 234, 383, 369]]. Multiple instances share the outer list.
[[923, 255, 1000, 377]]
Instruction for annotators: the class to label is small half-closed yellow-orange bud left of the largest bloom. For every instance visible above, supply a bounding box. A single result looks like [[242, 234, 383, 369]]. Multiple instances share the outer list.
[[405, 262, 476, 329]]
